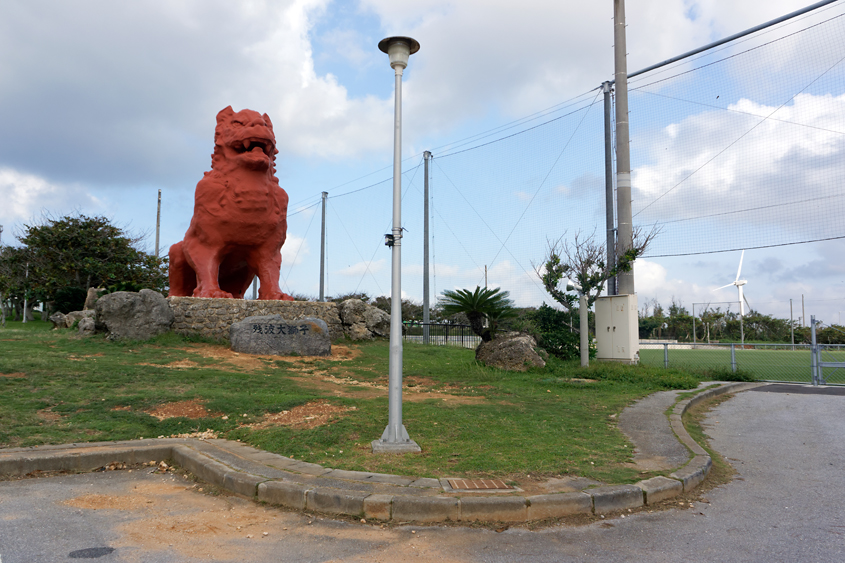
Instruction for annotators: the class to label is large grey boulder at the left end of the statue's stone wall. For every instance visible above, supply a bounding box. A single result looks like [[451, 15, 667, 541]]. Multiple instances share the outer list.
[[94, 289, 173, 340]]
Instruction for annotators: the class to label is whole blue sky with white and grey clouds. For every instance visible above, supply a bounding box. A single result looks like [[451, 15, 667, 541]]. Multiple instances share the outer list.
[[0, 0, 845, 322]]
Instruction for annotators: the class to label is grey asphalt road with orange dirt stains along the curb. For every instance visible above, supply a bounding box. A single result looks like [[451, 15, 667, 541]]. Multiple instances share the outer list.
[[0, 387, 845, 563]]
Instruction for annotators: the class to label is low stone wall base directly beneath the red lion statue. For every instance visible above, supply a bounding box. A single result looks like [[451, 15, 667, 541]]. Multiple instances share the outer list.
[[167, 297, 343, 340]]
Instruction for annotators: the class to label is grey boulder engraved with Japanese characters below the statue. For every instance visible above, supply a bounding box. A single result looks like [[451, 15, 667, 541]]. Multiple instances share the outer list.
[[229, 315, 332, 356]]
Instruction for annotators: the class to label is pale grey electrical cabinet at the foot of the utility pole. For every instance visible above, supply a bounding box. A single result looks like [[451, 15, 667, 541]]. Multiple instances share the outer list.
[[596, 294, 640, 363]]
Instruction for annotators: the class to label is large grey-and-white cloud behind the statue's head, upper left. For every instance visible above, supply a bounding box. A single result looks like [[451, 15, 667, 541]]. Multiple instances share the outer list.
[[0, 0, 392, 192]]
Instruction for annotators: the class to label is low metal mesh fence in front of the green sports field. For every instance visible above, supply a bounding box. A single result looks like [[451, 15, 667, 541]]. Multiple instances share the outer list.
[[640, 341, 845, 385]]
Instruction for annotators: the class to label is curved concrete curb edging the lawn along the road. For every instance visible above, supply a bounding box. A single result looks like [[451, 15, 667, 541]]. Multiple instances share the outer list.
[[0, 383, 765, 522]]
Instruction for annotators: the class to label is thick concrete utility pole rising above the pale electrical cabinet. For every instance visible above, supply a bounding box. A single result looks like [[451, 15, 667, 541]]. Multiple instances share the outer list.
[[613, 0, 636, 295]]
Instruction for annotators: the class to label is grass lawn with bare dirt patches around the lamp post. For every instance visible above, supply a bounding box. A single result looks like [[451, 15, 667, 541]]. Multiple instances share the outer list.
[[0, 322, 720, 482]]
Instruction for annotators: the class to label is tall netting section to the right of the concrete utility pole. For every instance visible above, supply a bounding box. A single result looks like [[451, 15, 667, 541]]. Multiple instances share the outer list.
[[629, 3, 845, 257]]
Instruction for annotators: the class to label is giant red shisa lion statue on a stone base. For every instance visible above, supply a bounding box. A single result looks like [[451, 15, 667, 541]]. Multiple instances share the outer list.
[[169, 106, 293, 301]]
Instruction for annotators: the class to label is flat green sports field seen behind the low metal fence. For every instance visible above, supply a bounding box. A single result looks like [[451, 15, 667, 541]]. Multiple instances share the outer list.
[[640, 345, 845, 384]]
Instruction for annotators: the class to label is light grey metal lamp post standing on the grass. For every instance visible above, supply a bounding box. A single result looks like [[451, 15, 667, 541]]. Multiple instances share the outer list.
[[372, 37, 421, 453]]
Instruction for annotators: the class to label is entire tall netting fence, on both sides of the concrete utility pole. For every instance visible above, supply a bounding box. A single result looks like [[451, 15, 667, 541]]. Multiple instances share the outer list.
[[282, 2, 845, 306]]
